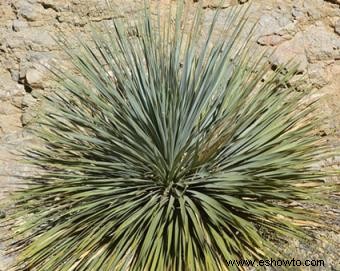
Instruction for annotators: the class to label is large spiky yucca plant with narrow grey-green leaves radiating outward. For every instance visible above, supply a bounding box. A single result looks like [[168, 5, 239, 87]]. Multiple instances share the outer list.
[[3, 0, 336, 271]]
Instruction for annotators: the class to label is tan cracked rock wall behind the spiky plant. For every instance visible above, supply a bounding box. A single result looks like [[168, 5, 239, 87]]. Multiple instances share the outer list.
[[0, 0, 340, 270]]
